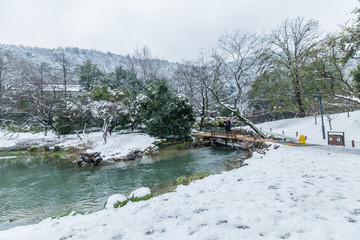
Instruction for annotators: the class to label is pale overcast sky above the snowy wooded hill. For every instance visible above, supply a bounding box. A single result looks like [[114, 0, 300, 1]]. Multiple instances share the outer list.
[[0, 0, 360, 62]]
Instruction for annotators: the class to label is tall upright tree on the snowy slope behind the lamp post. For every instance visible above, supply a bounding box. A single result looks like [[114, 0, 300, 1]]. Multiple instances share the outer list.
[[269, 17, 321, 117]]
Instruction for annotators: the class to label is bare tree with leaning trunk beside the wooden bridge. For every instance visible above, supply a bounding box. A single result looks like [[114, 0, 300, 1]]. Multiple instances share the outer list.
[[209, 32, 267, 138]]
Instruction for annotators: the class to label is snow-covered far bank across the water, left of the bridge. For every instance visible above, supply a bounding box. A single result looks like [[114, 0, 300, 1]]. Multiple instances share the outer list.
[[0, 130, 156, 159]]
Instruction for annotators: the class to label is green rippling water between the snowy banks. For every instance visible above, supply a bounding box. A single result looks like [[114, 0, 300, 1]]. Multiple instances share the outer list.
[[0, 148, 241, 230]]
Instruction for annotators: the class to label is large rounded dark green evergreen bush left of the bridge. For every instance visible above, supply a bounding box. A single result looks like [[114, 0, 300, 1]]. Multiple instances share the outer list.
[[138, 80, 195, 138]]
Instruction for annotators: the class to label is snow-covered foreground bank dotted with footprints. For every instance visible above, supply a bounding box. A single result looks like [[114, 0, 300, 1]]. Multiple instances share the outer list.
[[0, 145, 360, 240]]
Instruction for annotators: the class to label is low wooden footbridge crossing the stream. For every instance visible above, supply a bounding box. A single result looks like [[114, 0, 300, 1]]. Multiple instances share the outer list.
[[193, 130, 277, 148]]
